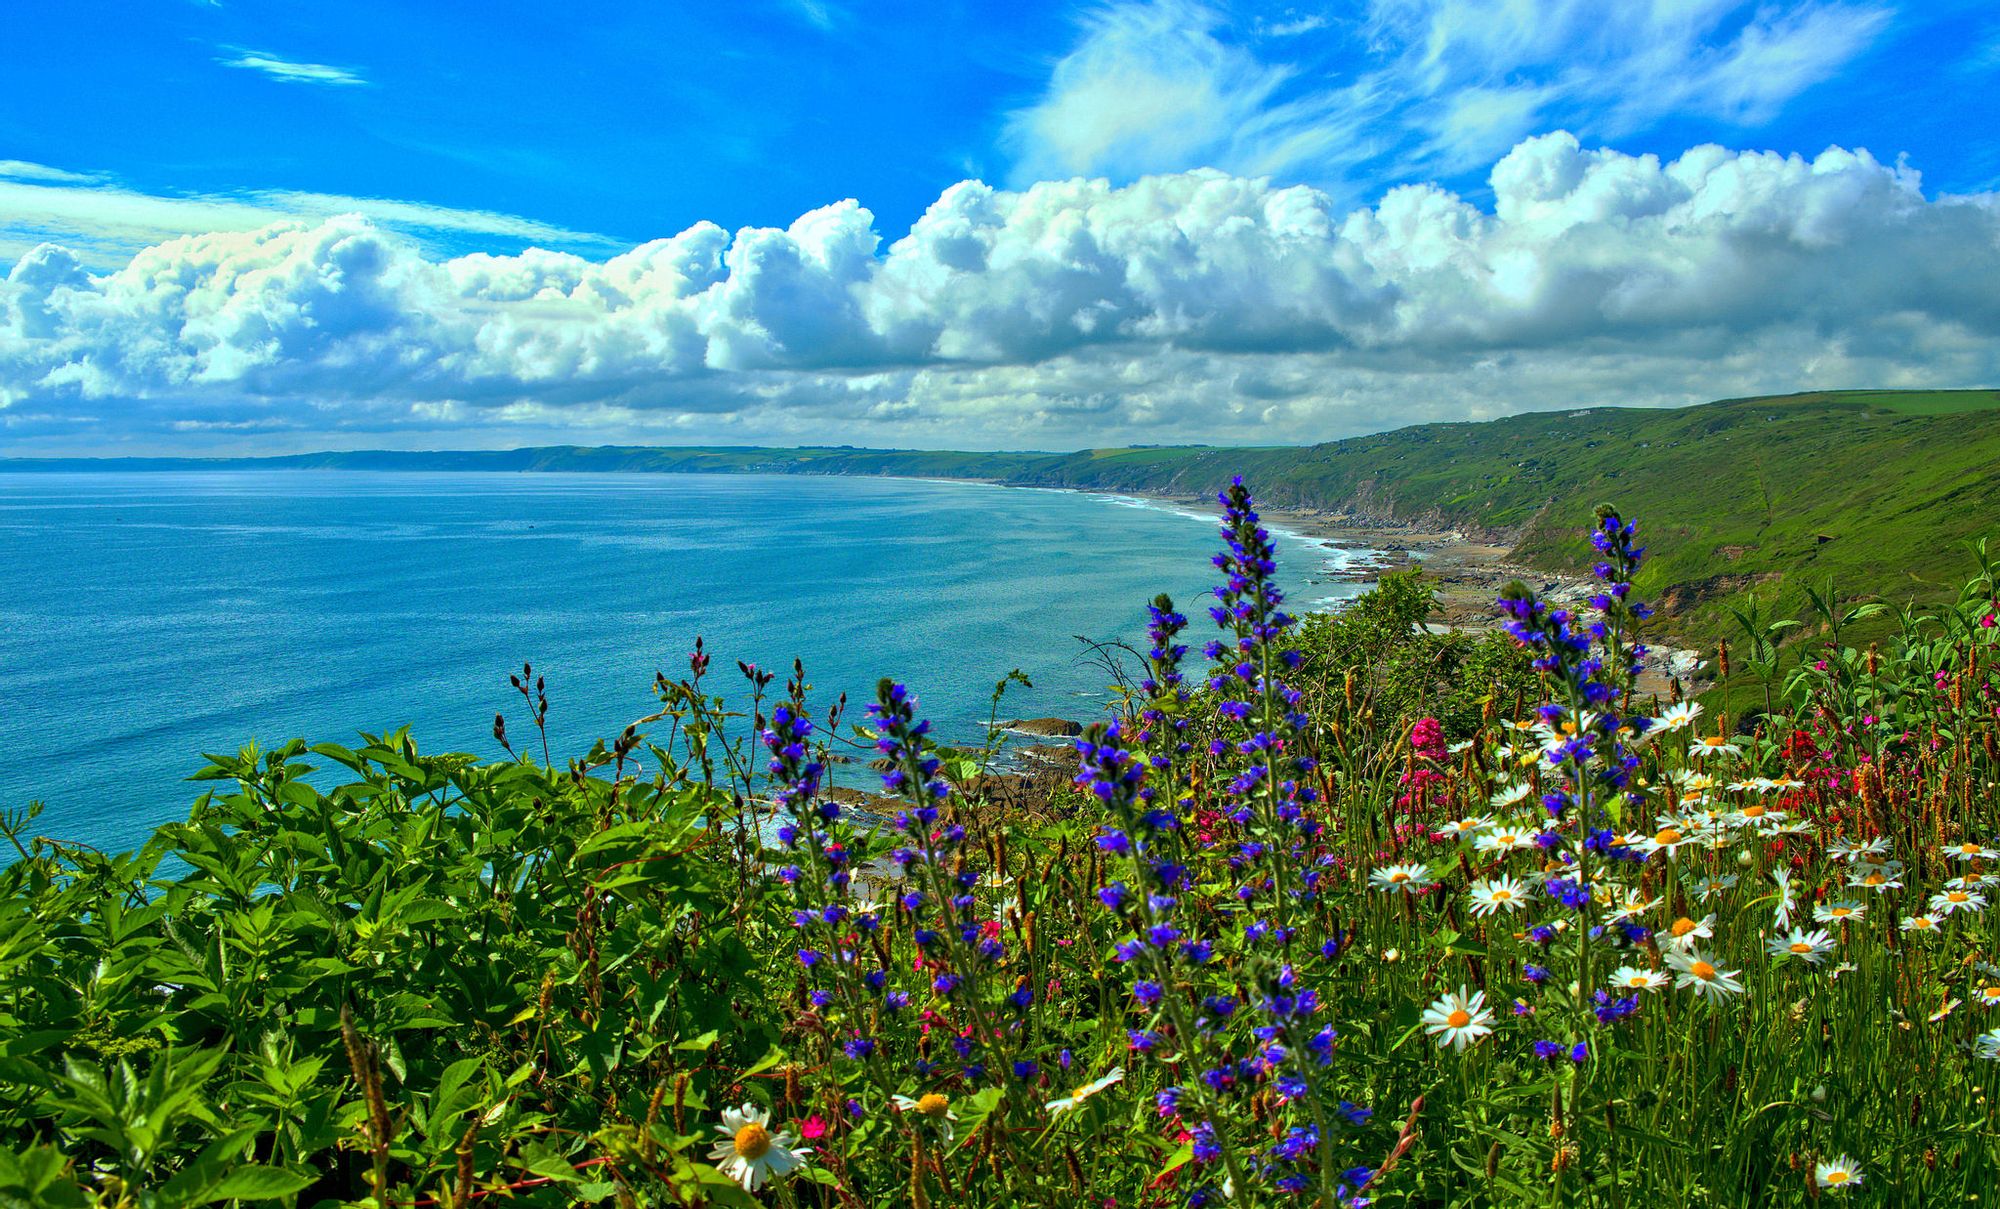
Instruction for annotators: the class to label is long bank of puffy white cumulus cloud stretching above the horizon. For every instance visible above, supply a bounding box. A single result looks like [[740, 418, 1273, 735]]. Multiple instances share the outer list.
[[0, 132, 2000, 448]]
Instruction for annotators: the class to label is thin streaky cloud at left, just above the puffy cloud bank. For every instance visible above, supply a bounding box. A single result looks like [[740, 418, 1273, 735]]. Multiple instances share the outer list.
[[0, 160, 622, 268]]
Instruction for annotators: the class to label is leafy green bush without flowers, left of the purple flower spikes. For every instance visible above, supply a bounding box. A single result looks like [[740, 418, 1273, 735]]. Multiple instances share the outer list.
[[0, 720, 760, 1207]]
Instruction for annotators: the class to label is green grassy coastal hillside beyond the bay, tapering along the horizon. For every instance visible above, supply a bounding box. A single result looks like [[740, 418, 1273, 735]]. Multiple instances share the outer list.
[[15, 390, 2000, 637]]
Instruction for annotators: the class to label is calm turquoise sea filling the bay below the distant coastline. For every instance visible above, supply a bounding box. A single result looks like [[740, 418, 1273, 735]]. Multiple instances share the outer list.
[[0, 470, 1358, 849]]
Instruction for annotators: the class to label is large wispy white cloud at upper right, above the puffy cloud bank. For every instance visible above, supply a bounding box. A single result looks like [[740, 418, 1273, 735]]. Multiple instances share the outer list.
[[1006, 0, 1892, 186]]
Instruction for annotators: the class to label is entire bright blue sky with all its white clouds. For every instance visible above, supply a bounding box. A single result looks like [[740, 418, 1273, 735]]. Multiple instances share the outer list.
[[0, 0, 2000, 454]]
